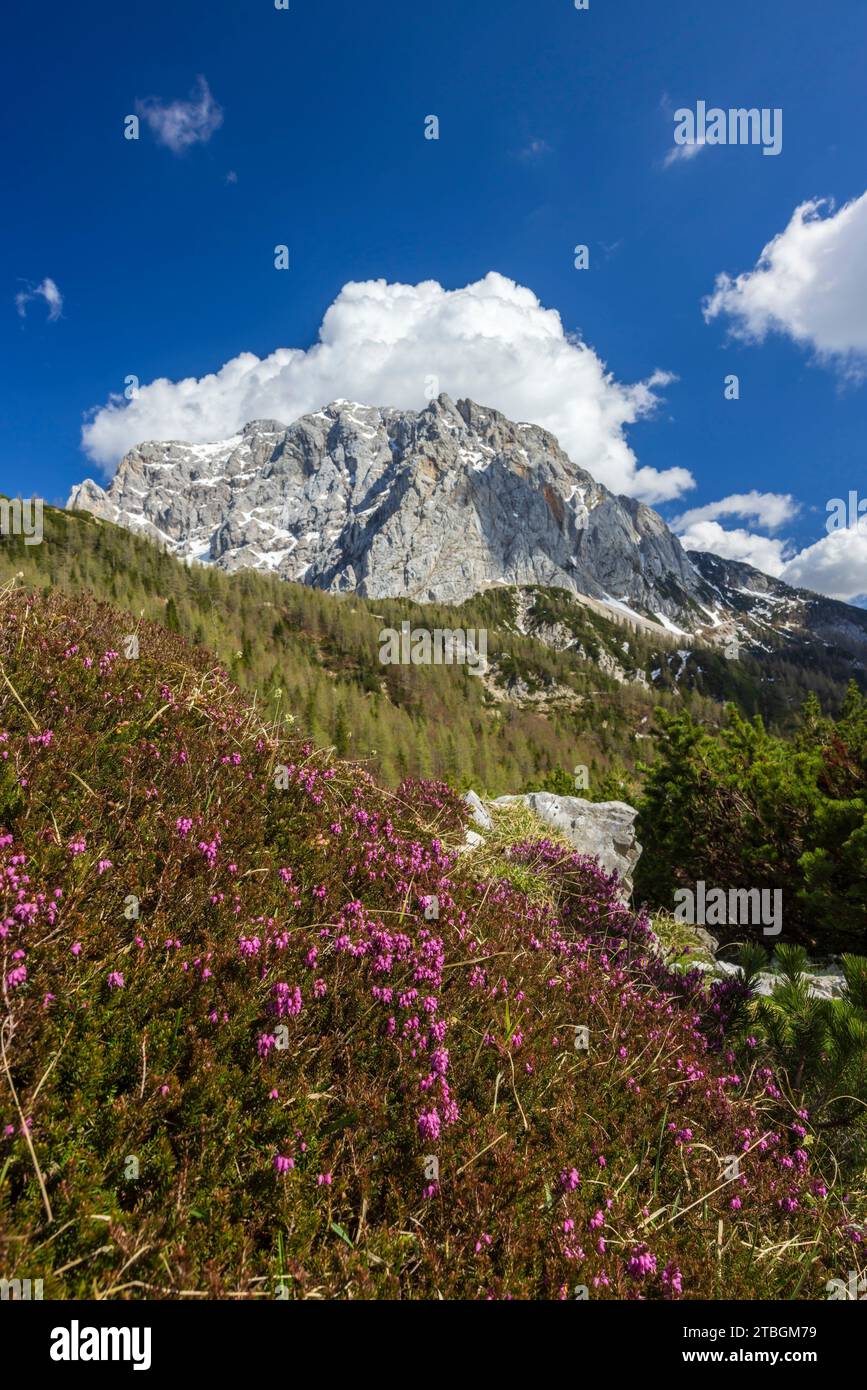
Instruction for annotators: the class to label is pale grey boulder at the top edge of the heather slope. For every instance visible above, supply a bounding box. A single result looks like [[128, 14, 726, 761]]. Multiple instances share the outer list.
[[492, 791, 641, 897]]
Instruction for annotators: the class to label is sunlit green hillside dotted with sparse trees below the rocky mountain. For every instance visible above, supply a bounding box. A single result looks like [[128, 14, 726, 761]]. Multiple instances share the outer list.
[[0, 507, 842, 796]]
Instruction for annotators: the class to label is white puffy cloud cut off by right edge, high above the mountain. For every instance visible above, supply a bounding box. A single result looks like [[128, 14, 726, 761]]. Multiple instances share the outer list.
[[703, 193, 867, 377]]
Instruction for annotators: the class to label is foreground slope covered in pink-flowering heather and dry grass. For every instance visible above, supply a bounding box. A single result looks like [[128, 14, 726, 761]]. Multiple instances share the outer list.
[[0, 589, 866, 1298]]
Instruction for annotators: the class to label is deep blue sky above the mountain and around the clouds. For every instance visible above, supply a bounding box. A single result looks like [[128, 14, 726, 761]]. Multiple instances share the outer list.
[[0, 0, 867, 596]]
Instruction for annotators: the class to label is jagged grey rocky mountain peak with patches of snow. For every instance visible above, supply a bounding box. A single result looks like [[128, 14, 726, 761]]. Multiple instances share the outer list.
[[67, 395, 714, 619]]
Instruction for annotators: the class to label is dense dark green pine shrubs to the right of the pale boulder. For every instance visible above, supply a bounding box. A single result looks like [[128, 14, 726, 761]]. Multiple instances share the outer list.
[[635, 695, 867, 954]]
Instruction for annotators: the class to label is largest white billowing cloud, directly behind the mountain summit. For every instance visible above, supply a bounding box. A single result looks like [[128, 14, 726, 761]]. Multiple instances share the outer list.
[[82, 271, 695, 502]]
